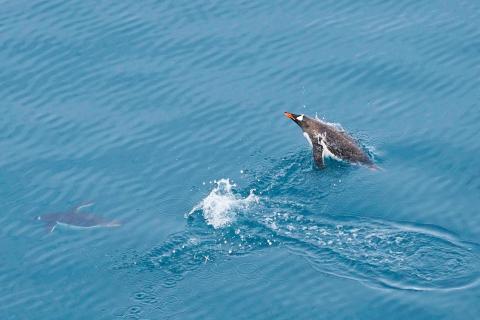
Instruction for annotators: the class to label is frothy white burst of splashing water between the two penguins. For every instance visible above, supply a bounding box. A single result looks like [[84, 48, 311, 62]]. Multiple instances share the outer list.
[[188, 179, 259, 229]]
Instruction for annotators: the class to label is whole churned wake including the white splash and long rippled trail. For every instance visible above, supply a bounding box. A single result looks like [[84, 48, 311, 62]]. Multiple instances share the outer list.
[[117, 156, 480, 290]]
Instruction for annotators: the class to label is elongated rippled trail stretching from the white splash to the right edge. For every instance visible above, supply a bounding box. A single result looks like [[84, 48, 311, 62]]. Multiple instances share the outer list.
[[265, 210, 480, 291]]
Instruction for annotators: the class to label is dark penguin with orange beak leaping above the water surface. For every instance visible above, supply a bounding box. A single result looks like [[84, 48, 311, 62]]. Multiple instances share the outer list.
[[284, 112, 377, 169]]
